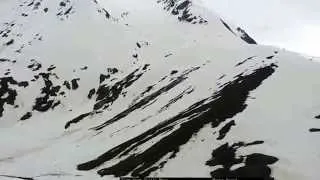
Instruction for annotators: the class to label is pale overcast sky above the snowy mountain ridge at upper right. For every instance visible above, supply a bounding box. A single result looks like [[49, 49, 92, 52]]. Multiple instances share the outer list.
[[201, 0, 320, 56]]
